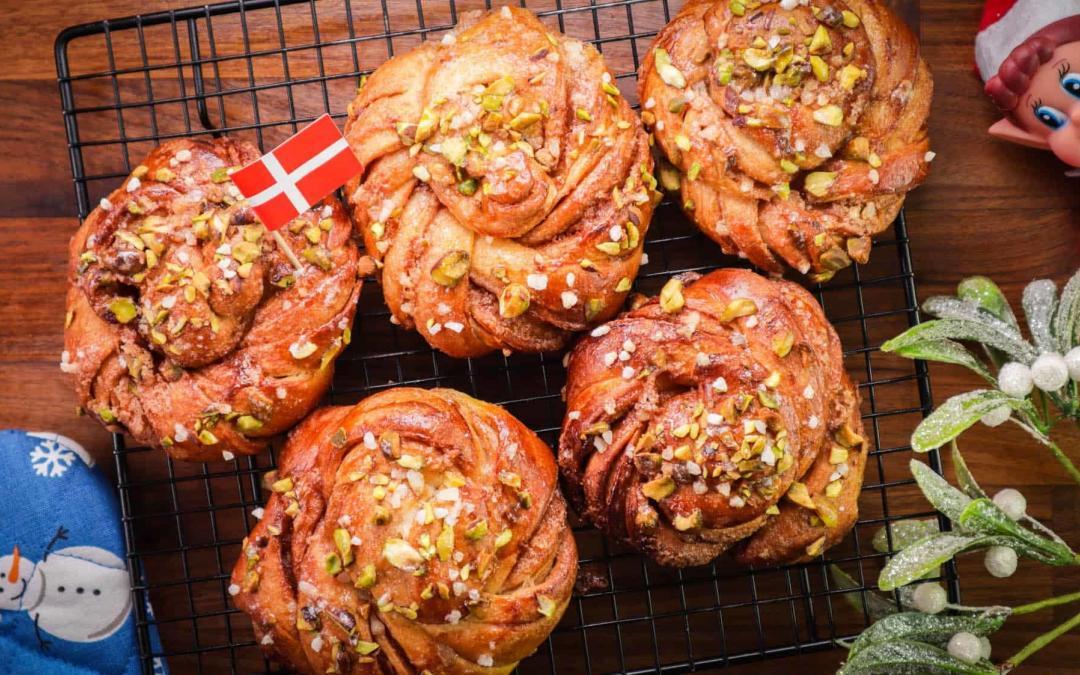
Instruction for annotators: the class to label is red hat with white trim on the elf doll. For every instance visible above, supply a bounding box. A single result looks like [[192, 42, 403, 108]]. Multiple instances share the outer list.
[[975, 0, 1080, 81]]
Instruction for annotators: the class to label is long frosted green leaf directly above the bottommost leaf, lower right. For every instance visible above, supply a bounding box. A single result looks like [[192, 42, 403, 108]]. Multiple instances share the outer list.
[[851, 610, 1009, 656]]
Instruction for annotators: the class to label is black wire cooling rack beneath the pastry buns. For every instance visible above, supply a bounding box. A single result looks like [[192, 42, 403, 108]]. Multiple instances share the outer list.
[[56, 0, 958, 673]]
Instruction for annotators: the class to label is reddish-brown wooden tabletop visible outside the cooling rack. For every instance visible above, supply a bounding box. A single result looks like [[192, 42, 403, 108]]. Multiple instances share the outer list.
[[0, 0, 1080, 673]]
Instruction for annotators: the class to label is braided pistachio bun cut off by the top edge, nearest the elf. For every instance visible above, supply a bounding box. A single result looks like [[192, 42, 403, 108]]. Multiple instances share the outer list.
[[639, 0, 933, 281]]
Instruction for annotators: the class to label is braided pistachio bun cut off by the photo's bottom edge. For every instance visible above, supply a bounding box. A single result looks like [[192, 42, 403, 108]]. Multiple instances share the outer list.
[[229, 388, 578, 675]]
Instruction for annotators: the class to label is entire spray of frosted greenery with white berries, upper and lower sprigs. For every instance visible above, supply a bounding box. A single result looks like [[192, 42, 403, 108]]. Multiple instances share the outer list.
[[832, 271, 1080, 675]]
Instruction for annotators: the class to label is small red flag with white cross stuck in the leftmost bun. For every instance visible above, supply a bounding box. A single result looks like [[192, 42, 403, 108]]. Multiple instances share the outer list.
[[230, 114, 364, 230]]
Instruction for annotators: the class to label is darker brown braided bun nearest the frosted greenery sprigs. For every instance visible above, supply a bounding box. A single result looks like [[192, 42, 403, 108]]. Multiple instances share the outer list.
[[558, 269, 866, 566]]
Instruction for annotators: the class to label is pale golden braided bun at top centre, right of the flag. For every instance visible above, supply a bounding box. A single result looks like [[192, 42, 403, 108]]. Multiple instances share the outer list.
[[345, 8, 660, 356]]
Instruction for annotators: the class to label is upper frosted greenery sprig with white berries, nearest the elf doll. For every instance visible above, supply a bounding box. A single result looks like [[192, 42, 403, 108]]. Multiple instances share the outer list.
[[881, 271, 1080, 484]]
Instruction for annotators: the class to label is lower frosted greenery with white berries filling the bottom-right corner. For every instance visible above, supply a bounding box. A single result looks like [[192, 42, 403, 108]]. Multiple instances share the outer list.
[[832, 443, 1080, 675]]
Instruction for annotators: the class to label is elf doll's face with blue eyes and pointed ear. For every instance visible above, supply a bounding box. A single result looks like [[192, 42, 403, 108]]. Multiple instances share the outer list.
[[990, 41, 1080, 166]]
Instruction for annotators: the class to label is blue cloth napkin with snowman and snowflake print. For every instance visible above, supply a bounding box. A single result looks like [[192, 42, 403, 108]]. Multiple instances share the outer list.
[[0, 430, 166, 675]]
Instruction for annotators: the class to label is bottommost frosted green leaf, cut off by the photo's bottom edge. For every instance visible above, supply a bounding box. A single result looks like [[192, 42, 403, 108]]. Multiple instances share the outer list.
[[837, 639, 998, 675]]
